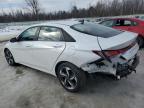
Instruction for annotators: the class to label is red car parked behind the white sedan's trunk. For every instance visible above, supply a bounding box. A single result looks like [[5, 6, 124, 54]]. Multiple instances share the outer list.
[[100, 18, 144, 47]]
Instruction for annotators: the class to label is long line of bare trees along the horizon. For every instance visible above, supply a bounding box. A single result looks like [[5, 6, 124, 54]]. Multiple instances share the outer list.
[[0, 0, 144, 22]]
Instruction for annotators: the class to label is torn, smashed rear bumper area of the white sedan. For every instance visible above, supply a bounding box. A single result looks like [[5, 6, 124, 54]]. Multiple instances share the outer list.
[[81, 55, 139, 77]]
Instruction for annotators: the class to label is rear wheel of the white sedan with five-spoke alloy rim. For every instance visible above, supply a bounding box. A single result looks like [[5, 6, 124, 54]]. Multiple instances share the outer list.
[[57, 63, 86, 92]]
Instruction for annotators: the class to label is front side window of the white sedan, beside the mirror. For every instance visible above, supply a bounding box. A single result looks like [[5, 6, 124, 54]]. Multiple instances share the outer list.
[[19, 27, 39, 41]]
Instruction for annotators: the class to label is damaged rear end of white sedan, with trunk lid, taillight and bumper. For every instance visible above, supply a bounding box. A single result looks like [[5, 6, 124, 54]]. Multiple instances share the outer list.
[[81, 32, 139, 79]]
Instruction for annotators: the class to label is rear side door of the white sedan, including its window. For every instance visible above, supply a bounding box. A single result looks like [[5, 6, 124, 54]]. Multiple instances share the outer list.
[[25, 26, 65, 73]]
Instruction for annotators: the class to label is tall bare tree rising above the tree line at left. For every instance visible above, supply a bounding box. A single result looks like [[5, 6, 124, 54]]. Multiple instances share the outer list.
[[25, 0, 40, 17]]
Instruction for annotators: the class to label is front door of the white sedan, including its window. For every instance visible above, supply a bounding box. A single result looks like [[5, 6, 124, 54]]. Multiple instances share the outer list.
[[11, 27, 39, 65]]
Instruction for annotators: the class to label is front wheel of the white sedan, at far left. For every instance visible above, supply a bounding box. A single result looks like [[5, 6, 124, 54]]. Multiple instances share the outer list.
[[4, 49, 16, 66]]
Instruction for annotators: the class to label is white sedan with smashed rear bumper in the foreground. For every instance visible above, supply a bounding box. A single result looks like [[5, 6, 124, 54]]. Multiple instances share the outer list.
[[4, 20, 139, 92]]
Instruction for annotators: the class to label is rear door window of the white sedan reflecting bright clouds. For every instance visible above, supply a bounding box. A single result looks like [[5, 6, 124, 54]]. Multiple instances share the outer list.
[[38, 27, 63, 41]]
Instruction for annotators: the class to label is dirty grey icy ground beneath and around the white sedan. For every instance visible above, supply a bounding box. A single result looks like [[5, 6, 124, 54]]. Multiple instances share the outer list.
[[0, 43, 144, 108]]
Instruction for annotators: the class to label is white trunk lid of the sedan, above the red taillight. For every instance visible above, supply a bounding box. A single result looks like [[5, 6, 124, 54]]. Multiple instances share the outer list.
[[98, 32, 138, 50]]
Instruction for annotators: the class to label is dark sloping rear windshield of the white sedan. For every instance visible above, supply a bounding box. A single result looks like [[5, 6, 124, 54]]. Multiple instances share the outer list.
[[71, 22, 122, 38]]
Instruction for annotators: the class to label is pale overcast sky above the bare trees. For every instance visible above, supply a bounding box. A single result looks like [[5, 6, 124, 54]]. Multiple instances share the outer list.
[[0, 0, 98, 12]]
